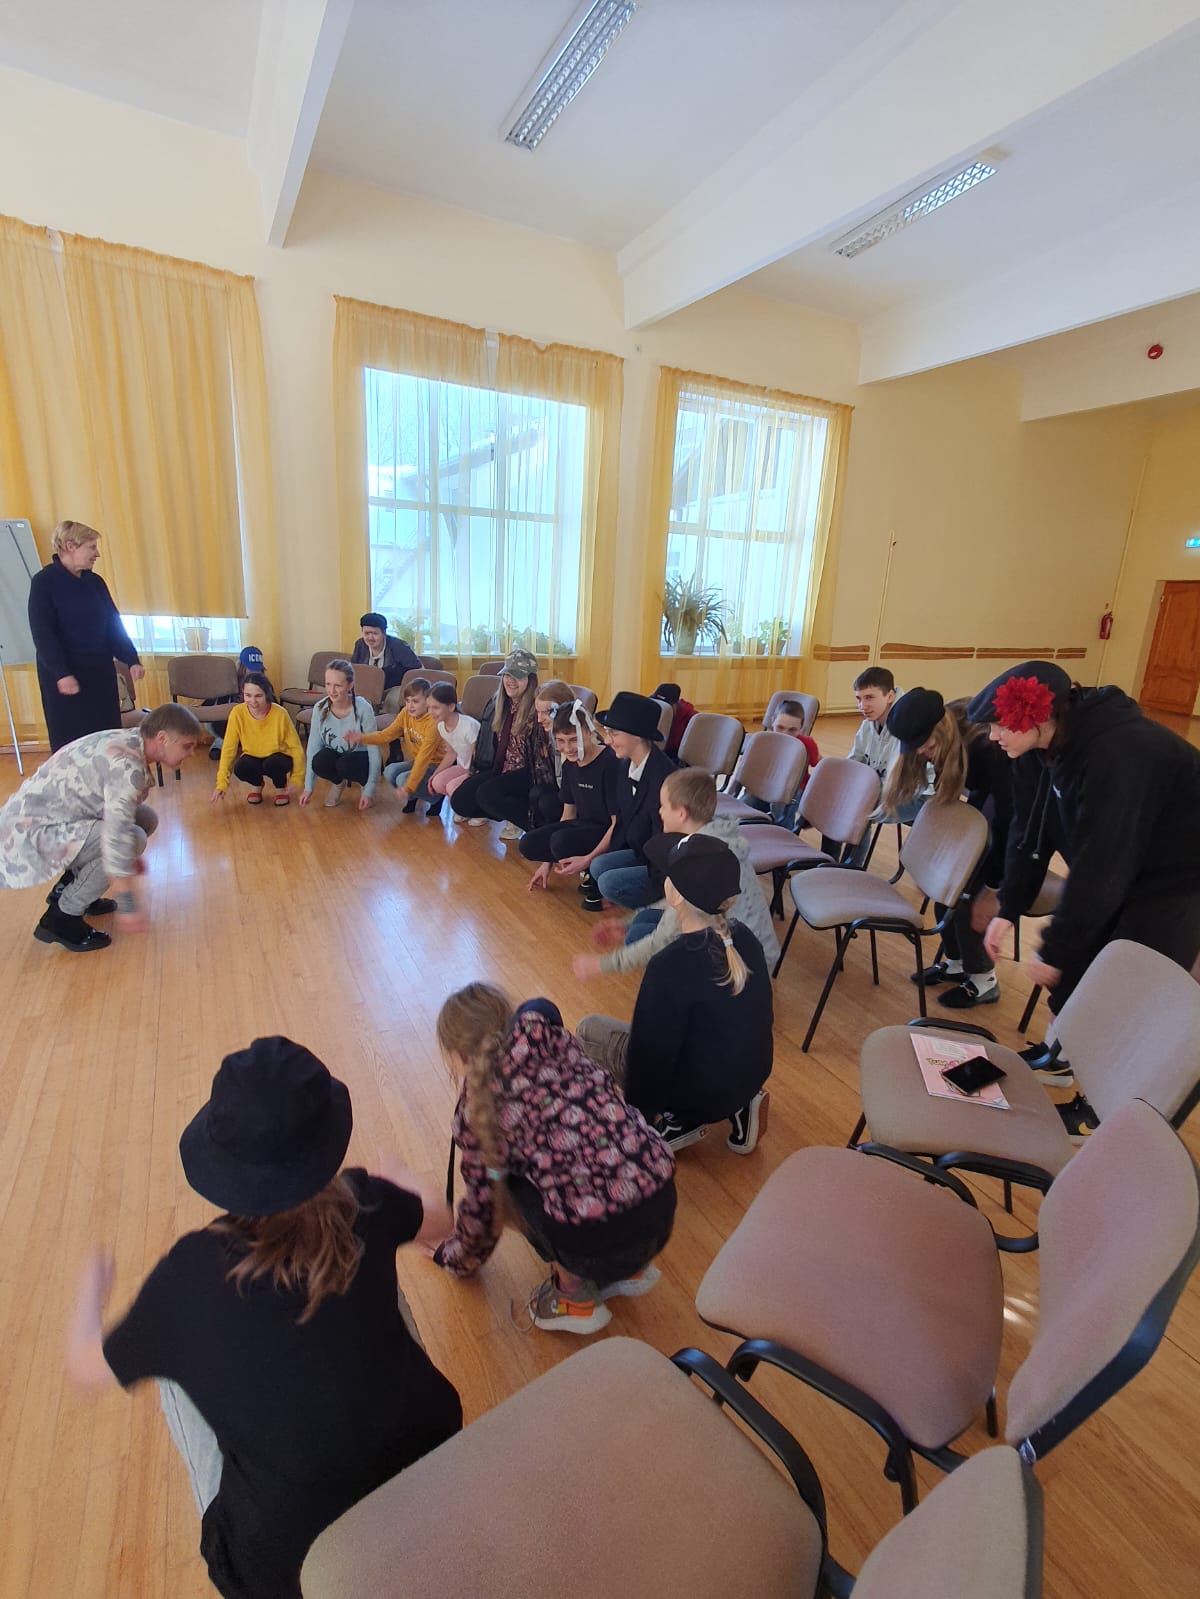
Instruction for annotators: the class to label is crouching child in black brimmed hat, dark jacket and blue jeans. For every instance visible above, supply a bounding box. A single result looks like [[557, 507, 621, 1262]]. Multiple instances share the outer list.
[[584, 692, 675, 910]]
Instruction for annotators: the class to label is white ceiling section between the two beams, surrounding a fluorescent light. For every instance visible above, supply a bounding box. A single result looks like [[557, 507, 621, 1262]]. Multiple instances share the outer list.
[[314, 0, 902, 249]]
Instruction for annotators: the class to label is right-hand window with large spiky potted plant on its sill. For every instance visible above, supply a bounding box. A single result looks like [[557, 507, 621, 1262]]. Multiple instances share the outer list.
[[661, 379, 830, 656]]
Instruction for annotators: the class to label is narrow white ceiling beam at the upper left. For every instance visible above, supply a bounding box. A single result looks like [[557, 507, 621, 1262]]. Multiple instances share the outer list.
[[246, 0, 354, 246]]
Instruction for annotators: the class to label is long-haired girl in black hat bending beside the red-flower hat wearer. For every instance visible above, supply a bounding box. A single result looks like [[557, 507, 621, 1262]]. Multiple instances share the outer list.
[[883, 689, 1013, 1011]]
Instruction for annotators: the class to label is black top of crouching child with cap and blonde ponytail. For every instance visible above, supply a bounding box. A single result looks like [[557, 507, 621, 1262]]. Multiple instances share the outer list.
[[626, 921, 774, 1122]]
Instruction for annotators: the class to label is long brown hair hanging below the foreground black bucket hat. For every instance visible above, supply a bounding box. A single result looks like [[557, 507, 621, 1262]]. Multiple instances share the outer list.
[[213, 1177, 363, 1327]]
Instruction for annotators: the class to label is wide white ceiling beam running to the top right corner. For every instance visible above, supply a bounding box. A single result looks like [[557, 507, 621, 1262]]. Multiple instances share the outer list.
[[618, 0, 1200, 328]]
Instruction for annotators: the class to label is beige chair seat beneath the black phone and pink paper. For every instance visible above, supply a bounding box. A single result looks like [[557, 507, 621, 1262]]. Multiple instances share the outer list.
[[859, 1025, 1075, 1177]]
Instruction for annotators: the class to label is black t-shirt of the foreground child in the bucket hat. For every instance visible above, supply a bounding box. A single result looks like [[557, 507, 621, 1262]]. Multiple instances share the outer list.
[[104, 1169, 462, 1599]]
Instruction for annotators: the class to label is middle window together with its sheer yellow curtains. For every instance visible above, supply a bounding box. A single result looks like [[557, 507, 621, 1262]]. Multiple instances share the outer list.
[[333, 299, 622, 696]]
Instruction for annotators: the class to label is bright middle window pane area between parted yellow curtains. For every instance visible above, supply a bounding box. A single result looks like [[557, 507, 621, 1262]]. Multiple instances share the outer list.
[[363, 366, 587, 656]]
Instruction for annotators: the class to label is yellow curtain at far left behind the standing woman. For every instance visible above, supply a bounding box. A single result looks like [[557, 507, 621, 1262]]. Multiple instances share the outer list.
[[0, 217, 278, 734]]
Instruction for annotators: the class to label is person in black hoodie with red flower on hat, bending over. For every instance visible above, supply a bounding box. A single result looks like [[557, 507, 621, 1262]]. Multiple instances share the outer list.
[[968, 660, 1200, 1130]]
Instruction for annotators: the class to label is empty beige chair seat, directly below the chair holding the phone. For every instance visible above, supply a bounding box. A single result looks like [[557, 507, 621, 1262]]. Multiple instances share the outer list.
[[700, 1148, 1003, 1451]]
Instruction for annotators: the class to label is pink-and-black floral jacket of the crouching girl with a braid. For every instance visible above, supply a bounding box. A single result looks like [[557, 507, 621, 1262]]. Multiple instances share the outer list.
[[438, 1015, 675, 1276]]
